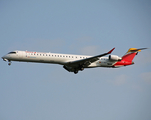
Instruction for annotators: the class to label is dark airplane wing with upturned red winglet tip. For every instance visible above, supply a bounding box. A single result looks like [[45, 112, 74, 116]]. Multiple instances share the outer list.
[[66, 48, 115, 67]]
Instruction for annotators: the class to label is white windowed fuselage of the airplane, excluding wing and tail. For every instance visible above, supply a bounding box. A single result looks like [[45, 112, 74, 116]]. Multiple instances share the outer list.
[[3, 51, 116, 68]]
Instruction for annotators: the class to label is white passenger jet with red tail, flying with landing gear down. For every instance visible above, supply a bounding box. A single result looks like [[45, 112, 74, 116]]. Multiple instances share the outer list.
[[2, 47, 147, 74]]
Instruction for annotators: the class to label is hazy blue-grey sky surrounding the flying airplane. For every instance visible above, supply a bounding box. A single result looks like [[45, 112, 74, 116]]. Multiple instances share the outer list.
[[0, 0, 151, 120]]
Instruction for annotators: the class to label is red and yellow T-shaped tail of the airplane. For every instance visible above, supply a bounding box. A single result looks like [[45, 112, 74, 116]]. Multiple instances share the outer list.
[[114, 48, 147, 67]]
